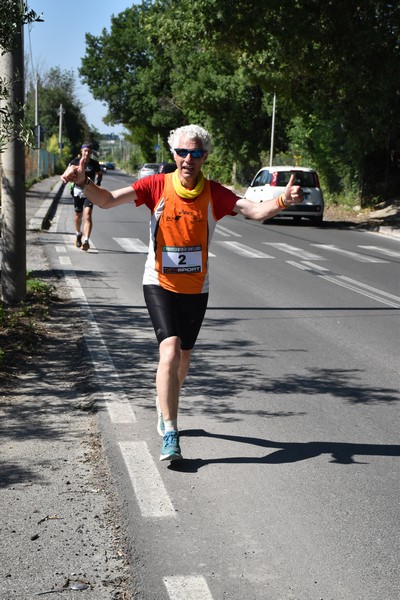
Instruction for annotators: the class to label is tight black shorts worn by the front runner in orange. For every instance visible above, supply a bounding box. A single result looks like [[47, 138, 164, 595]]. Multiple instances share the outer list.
[[143, 285, 208, 350]]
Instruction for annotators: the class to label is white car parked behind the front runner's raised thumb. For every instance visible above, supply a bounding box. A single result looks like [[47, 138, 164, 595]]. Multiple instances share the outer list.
[[244, 166, 324, 224]]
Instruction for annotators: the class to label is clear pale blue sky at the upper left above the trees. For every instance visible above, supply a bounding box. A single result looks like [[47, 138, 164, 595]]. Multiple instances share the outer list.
[[24, 0, 139, 135]]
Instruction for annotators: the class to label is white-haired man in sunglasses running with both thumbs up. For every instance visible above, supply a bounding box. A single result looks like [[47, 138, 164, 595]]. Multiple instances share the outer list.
[[62, 125, 303, 460]]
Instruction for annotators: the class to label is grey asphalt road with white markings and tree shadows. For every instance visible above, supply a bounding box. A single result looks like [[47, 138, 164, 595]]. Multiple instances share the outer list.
[[47, 172, 400, 600]]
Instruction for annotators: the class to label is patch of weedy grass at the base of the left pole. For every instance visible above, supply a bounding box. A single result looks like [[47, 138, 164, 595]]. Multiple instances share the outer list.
[[0, 273, 57, 376]]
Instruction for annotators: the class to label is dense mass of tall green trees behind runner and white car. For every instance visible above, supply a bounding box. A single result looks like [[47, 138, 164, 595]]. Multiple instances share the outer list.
[[81, 0, 400, 195]]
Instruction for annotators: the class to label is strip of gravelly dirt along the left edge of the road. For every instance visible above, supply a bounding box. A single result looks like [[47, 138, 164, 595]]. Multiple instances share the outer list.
[[0, 233, 133, 600]]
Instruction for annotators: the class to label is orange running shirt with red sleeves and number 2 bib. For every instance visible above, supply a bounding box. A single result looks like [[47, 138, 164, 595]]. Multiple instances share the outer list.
[[132, 173, 238, 294]]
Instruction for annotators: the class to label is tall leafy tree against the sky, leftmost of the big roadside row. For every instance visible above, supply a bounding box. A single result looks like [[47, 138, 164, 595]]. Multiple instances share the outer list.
[[80, 3, 182, 160]]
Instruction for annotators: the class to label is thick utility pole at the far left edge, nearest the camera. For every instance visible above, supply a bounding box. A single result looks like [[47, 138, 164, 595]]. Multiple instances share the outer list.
[[0, 9, 26, 305]]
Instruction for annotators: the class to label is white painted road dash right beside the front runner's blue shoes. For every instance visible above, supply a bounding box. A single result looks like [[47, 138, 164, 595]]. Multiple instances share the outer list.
[[118, 442, 176, 516]]
